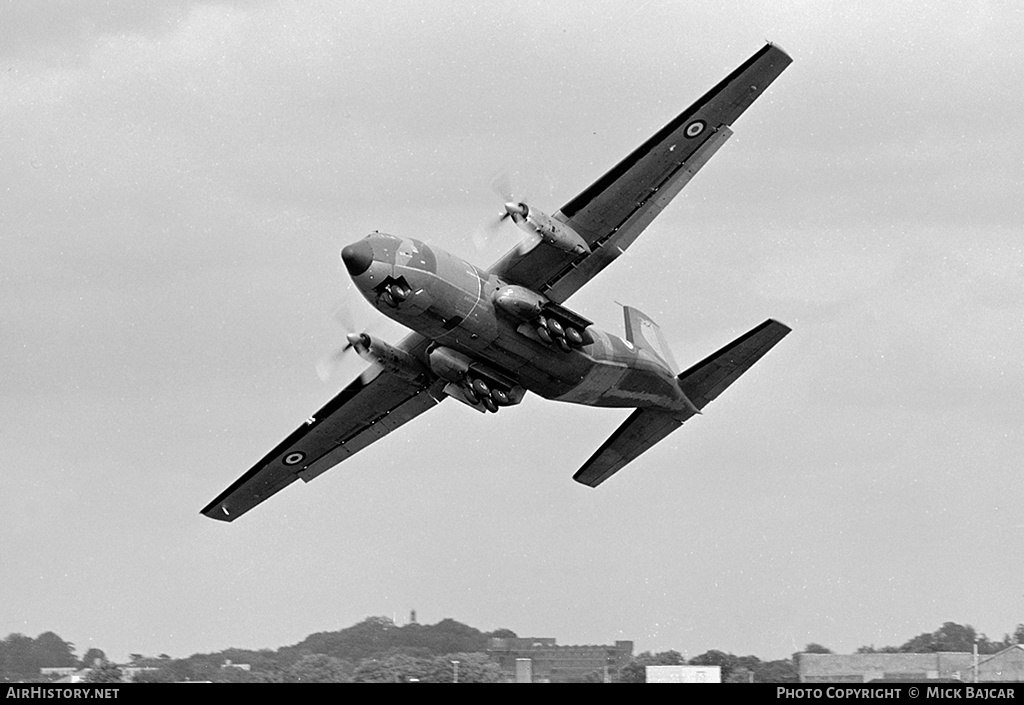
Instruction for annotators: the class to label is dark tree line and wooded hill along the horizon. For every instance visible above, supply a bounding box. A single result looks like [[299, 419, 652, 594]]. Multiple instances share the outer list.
[[0, 617, 1024, 682]]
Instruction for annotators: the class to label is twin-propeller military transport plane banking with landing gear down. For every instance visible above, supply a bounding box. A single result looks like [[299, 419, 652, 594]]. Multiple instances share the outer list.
[[203, 44, 793, 522]]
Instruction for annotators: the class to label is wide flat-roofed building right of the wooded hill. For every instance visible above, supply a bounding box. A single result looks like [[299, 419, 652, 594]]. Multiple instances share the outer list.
[[487, 636, 633, 682]]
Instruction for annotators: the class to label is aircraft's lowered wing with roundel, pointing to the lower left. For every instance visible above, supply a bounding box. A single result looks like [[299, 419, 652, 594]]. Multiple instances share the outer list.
[[202, 333, 445, 522]]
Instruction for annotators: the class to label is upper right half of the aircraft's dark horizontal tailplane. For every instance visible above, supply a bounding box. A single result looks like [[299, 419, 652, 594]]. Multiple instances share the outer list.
[[679, 319, 790, 409]]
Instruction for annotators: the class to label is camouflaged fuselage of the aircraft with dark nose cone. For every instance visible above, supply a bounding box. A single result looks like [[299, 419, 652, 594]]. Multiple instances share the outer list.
[[342, 233, 690, 411]]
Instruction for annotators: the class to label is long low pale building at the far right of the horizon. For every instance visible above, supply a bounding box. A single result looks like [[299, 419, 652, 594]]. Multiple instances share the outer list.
[[797, 645, 1024, 682]]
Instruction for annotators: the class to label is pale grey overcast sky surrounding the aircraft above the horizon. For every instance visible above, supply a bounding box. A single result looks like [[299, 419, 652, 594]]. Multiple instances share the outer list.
[[0, 0, 1024, 659]]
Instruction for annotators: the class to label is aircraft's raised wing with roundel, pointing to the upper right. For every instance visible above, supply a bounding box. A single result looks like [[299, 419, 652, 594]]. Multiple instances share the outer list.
[[490, 44, 793, 303]]
